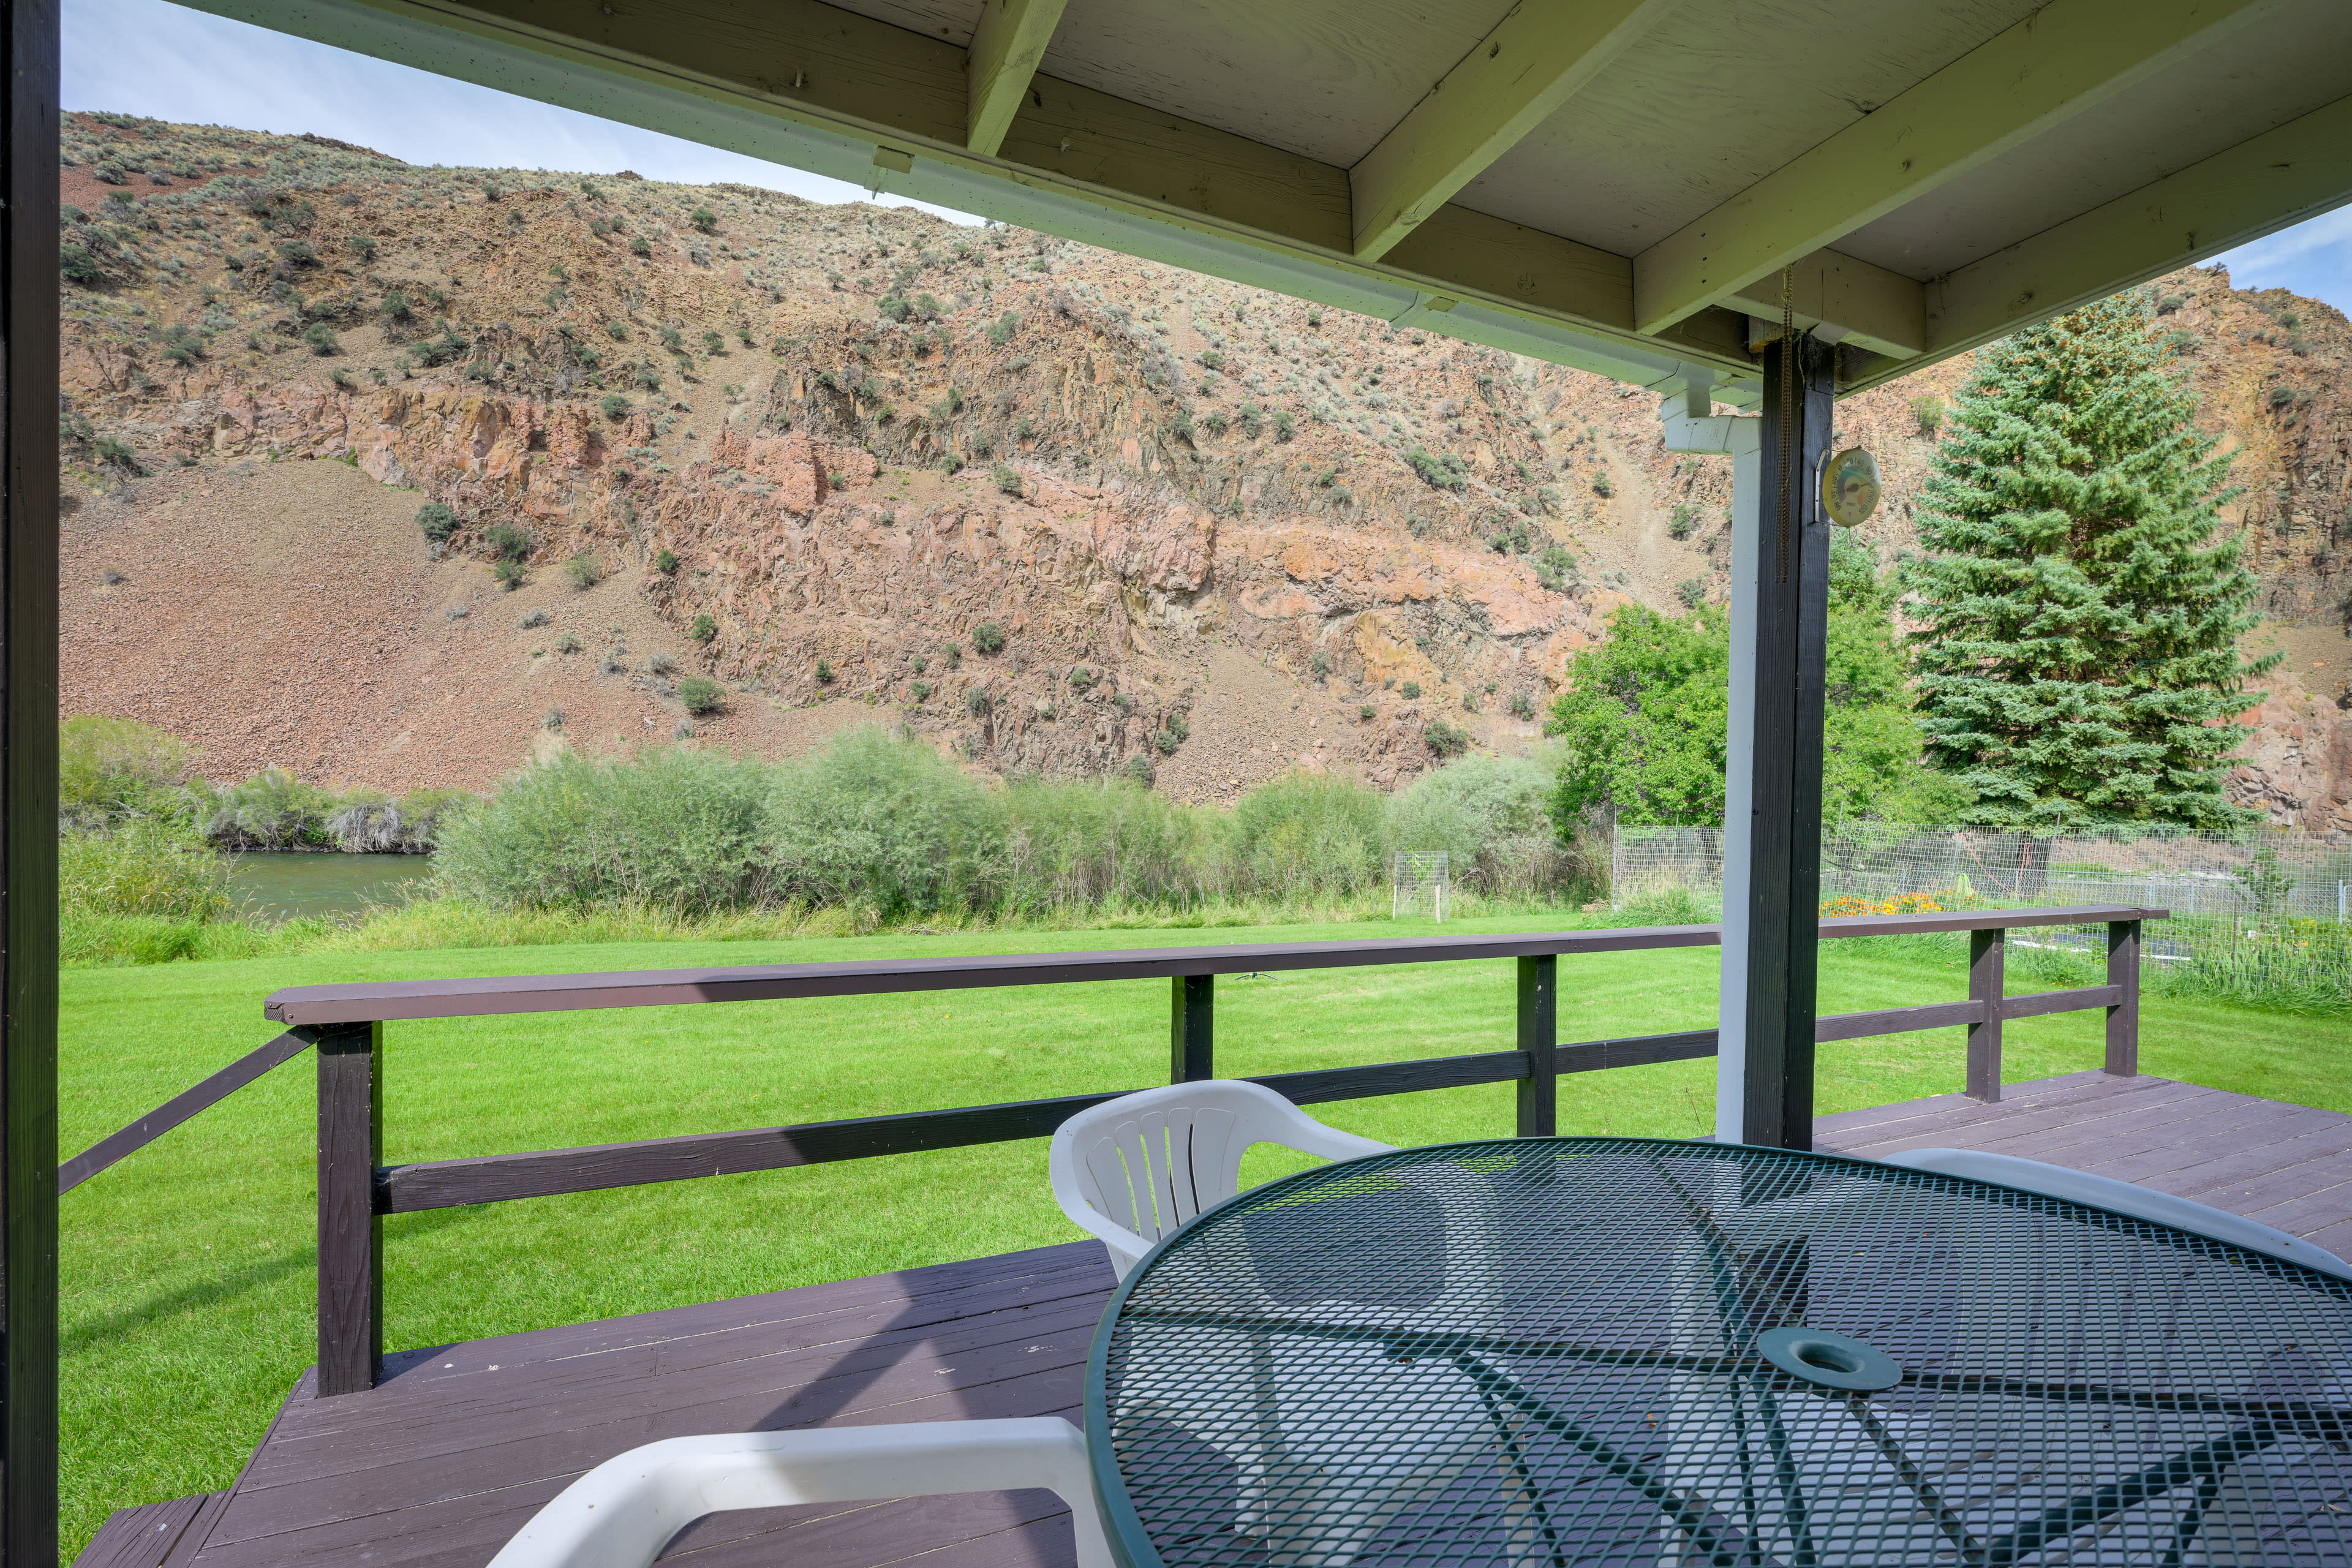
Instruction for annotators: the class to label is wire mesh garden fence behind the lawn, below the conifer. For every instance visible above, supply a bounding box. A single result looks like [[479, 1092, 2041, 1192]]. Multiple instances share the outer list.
[[1609, 823, 2352, 1001]]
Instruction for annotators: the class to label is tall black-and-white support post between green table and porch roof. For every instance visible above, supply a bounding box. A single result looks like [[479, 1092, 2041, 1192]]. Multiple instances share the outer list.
[[1714, 331, 1837, 1150]]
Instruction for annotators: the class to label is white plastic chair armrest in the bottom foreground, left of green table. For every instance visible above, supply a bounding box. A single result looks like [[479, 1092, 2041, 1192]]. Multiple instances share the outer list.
[[489, 1415, 1110, 1568]]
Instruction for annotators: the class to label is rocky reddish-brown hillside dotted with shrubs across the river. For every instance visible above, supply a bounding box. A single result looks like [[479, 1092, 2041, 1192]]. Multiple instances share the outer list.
[[61, 115, 2352, 825]]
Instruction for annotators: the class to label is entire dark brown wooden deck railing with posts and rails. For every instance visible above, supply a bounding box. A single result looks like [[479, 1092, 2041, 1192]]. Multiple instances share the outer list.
[[66, 905, 2166, 1396]]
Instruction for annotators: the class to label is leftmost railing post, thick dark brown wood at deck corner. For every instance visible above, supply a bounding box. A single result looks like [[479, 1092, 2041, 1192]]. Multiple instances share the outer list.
[[317, 1023, 383, 1399]]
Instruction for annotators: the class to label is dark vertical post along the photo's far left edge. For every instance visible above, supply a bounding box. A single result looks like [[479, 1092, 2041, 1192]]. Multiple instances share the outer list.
[[0, 0, 56, 1568]]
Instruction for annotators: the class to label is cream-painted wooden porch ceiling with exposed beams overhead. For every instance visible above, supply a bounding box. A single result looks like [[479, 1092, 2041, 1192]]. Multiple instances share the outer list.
[[165, 0, 2352, 404]]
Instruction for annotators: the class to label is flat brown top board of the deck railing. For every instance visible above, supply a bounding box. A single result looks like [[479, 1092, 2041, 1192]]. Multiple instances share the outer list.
[[261, 903, 2166, 1025]]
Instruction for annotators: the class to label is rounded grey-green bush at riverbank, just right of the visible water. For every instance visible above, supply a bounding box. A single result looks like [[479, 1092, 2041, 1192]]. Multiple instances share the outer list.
[[433, 748, 774, 912]]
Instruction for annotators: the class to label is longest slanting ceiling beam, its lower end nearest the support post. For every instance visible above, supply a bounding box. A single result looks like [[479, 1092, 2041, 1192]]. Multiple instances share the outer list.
[[1635, 0, 2286, 331]]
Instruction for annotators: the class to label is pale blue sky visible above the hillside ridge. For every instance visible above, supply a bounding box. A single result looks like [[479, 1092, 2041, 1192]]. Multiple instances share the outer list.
[[66, 0, 2352, 312]]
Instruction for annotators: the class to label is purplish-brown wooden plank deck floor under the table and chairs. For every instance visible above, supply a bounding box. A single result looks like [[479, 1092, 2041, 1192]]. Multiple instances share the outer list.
[[78, 1072, 2352, 1568]]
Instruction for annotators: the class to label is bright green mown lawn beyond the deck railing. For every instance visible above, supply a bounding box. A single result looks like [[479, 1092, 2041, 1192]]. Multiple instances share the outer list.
[[61, 917, 2352, 1554]]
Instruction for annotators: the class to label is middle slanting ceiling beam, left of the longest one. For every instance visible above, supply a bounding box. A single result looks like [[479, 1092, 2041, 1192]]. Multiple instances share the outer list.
[[1348, 0, 1677, 261]]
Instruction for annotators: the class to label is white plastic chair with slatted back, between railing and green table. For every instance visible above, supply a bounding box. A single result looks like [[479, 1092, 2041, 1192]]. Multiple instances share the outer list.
[[1047, 1079, 1395, 1279]]
